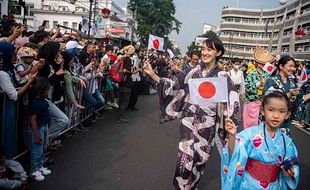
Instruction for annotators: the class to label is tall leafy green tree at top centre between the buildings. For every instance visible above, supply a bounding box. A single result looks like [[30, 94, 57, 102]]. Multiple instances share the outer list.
[[129, 0, 182, 48]]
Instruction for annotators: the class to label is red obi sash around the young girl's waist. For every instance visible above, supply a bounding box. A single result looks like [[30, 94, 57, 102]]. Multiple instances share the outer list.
[[245, 158, 279, 183]]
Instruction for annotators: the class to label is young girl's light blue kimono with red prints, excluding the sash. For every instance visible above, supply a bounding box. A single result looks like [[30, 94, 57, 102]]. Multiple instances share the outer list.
[[221, 122, 299, 190]]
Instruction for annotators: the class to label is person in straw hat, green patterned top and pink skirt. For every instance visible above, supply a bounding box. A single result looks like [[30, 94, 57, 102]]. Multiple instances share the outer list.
[[243, 47, 275, 129]]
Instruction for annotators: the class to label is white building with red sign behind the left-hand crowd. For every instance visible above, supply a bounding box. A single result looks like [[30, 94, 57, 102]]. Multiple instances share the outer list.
[[10, 0, 137, 41]]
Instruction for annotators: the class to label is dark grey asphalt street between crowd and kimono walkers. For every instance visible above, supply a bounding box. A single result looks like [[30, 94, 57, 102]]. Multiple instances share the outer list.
[[29, 96, 310, 190]]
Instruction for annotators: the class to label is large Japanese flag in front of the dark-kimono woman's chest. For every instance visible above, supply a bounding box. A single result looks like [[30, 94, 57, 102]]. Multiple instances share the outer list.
[[188, 77, 228, 105]]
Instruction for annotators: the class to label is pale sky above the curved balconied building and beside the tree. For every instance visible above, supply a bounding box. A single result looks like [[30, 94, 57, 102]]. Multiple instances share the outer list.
[[114, 0, 294, 53]]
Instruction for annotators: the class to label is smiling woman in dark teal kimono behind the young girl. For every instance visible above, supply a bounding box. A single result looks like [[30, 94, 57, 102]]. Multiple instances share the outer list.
[[264, 55, 308, 135]]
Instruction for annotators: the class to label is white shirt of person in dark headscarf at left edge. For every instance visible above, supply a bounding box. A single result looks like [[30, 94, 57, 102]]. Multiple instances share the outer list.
[[0, 71, 18, 101]]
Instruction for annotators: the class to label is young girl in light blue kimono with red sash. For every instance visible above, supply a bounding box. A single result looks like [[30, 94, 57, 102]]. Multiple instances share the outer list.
[[221, 90, 299, 190]]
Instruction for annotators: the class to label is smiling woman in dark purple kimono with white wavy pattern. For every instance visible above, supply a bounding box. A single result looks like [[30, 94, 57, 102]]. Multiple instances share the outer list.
[[144, 38, 239, 190]]
